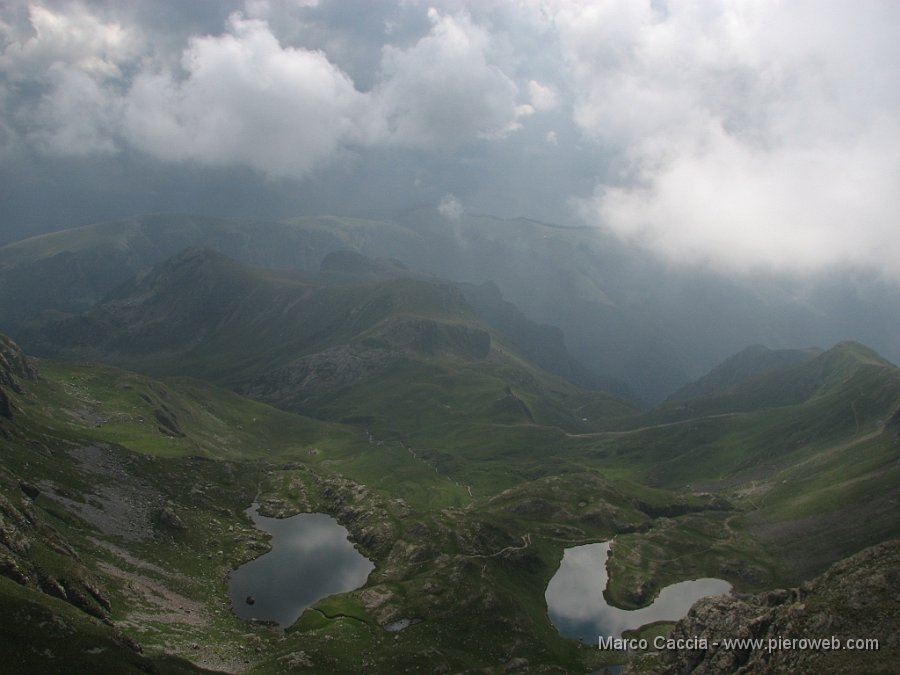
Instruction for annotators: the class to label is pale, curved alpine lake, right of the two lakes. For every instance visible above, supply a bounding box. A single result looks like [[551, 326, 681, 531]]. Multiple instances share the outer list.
[[545, 541, 731, 645]]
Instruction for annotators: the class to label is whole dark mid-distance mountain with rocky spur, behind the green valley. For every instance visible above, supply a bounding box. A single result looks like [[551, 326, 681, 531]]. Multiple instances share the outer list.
[[22, 249, 634, 438]]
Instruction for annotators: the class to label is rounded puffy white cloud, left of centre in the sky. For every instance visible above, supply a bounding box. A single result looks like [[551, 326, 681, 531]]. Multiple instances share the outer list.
[[123, 15, 371, 178]]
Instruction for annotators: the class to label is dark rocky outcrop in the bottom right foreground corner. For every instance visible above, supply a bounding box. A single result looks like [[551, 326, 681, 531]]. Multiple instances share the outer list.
[[625, 541, 900, 675]]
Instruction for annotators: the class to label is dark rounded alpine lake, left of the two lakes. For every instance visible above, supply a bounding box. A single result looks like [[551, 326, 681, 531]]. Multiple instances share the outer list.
[[228, 504, 375, 628]]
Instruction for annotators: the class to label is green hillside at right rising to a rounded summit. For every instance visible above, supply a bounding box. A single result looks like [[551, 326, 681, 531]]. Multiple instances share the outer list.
[[567, 342, 900, 596]]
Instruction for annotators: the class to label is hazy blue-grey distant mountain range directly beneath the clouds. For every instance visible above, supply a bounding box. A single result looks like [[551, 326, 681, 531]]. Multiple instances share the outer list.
[[0, 209, 900, 403]]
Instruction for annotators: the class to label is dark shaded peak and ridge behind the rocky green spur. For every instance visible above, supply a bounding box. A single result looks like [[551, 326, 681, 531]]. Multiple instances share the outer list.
[[19, 249, 478, 374]]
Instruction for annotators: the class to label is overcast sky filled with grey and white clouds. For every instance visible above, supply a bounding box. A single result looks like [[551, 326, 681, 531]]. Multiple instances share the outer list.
[[0, 0, 900, 280]]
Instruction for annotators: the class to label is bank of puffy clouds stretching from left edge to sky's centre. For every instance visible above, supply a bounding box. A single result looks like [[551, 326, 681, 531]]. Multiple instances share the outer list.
[[0, 0, 532, 179]]
